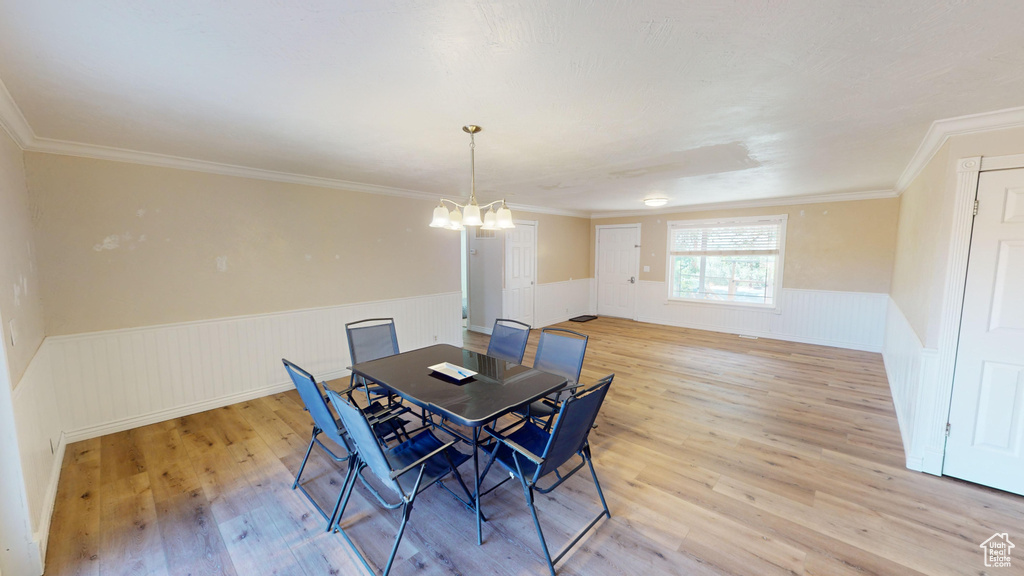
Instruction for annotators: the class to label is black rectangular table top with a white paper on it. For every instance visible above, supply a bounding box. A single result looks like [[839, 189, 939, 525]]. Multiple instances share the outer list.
[[352, 344, 566, 426]]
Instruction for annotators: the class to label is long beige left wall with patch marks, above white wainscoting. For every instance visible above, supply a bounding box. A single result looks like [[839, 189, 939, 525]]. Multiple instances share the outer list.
[[22, 153, 460, 335]]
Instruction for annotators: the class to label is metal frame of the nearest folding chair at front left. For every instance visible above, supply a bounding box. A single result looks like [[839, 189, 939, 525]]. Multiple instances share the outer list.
[[328, 390, 473, 576]]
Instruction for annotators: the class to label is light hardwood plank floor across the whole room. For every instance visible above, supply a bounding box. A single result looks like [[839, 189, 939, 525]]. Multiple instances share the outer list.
[[46, 319, 1024, 576]]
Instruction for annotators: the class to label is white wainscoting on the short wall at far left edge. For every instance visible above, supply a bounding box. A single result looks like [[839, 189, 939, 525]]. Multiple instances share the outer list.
[[11, 343, 65, 559]]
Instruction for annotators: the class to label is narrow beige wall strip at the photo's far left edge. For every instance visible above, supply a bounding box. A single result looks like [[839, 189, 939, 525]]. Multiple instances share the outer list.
[[0, 130, 43, 387]]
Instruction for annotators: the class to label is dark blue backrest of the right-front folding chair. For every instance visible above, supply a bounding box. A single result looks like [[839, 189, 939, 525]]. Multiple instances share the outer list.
[[534, 374, 615, 482]]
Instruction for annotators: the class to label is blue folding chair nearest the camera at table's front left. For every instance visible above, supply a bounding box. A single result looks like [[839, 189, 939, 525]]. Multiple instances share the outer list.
[[328, 390, 472, 576]]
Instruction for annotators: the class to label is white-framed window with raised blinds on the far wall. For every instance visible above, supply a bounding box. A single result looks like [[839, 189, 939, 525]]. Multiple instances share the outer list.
[[668, 214, 786, 307]]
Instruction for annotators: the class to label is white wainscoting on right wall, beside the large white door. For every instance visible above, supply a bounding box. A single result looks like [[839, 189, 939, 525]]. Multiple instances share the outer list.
[[882, 298, 945, 475]]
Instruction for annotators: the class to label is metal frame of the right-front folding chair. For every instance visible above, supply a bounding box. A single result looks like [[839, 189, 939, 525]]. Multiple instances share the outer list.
[[480, 374, 615, 576]]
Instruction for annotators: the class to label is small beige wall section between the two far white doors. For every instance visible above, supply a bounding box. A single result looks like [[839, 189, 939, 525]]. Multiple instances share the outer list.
[[513, 210, 593, 284]]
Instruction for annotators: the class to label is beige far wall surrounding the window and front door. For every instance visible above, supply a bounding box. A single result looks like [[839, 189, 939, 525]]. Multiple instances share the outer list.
[[589, 198, 899, 293]]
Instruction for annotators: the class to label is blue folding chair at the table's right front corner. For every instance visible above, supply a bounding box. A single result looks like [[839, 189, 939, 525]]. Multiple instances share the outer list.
[[480, 374, 615, 576]]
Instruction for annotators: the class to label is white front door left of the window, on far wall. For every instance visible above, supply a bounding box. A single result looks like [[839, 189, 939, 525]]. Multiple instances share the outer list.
[[597, 224, 640, 319]]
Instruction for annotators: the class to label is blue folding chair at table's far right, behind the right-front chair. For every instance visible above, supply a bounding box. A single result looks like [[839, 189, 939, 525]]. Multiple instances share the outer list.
[[505, 328, 589, 429]]
